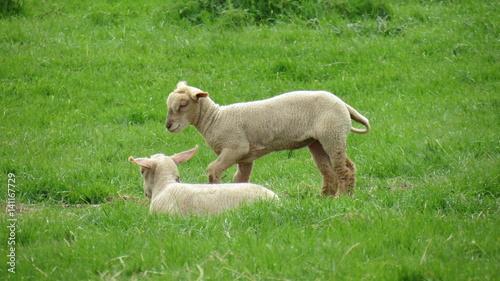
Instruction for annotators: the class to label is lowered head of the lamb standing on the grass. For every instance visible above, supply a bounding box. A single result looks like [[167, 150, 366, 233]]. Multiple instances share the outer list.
[[165, 81, 208, 133]]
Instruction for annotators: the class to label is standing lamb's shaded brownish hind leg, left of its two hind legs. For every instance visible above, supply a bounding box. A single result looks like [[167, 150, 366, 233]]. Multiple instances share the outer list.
[[308, 142, 337, 196]]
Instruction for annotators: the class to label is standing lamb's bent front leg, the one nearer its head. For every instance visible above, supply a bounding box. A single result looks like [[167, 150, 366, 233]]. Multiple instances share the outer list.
[[207, 146, 251, 183]]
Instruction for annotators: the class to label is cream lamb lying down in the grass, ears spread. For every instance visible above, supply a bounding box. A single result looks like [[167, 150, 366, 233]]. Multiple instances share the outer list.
[[128, 146, 279, 215]]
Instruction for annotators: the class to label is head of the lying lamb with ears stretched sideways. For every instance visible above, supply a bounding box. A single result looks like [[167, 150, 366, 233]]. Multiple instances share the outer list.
[[128, 146, 198, 198]]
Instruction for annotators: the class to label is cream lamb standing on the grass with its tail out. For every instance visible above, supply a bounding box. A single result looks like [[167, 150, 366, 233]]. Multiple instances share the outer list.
[[166, 81, 370, 196]]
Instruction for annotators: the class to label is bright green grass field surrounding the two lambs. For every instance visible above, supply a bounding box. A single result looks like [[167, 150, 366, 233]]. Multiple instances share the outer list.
[[0, 0, 500, 281]]
